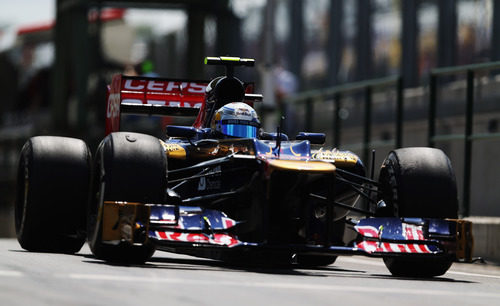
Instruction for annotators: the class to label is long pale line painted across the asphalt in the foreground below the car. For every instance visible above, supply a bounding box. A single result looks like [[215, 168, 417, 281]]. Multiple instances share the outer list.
[[69, 274, 500, 299]]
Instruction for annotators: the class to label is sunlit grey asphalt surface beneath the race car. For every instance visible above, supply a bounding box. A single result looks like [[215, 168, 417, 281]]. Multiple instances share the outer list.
[[0, 239, 500, 306]]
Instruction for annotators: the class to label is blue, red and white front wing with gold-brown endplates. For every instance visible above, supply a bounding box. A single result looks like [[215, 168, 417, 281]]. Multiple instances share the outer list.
[[102, 201, 473, 261]]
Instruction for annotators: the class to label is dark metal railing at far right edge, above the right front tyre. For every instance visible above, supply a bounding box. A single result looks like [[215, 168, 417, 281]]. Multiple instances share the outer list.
[[427, 62, 500, 216]]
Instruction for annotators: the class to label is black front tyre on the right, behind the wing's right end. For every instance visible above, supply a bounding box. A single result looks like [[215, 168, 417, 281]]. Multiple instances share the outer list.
[[379, 148, 458, 277]]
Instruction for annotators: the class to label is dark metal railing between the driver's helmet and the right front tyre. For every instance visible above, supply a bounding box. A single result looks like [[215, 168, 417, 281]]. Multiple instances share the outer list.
[[286, 76, 403, 167]]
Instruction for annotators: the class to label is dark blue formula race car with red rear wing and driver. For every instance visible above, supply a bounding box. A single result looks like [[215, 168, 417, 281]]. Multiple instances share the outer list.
[[15, 57, 472, 277]]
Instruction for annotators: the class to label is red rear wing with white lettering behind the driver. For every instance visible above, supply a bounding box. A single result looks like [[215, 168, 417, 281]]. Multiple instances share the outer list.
[[106, 75, 208, 135]]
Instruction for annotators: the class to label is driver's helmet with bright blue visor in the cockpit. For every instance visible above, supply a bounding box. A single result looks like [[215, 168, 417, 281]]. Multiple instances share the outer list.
[[211, 102, 260, 138]]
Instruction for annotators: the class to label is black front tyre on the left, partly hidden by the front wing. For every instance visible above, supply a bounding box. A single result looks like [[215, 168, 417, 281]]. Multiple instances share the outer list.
[[88, 132, 167, 263]]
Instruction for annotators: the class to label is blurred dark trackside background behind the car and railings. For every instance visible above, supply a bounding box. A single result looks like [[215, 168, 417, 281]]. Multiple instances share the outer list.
[[0, 0, 500, 236]]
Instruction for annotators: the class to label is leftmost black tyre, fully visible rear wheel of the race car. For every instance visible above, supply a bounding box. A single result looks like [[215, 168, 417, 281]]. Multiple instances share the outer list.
[[15, 136, 91, 253]]
